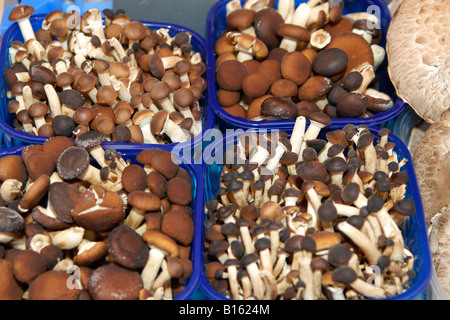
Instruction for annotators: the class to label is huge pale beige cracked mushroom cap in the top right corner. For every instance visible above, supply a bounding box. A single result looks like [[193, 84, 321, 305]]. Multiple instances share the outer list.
[[386, 0, 449, 123]]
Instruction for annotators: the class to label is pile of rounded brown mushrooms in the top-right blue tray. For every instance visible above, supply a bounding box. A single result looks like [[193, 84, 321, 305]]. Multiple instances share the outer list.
[[214, 0, 393, 121]]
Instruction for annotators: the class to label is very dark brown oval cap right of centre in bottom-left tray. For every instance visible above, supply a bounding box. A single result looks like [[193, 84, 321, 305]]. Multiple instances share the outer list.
[[108, 225, 149, 269]]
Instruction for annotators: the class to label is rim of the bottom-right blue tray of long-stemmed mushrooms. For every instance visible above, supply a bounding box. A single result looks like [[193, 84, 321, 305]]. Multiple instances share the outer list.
[[200, 125, 433, 300]]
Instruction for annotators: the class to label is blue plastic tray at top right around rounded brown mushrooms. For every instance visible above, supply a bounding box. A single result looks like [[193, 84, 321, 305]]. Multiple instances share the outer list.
[[206, 0, 404, 130]]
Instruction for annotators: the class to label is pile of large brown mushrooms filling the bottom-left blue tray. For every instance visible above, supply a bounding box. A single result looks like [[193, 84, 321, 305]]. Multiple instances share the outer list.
[[0, 131, 194, 300]]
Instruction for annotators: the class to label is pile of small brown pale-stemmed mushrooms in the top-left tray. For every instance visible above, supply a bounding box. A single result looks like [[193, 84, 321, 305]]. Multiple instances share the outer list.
[[4, 5, 206, 144]]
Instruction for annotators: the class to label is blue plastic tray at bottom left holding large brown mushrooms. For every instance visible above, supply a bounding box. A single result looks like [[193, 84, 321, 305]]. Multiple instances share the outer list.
[[0, 145, 204, 300]]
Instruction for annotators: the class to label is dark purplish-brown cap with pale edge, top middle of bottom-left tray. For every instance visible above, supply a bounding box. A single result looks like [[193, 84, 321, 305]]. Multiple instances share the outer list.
[[56, 146, 90, 180]]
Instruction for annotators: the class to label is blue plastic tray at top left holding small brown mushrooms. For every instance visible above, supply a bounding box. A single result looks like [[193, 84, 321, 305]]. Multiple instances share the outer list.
[[0, 14, 215, 154]]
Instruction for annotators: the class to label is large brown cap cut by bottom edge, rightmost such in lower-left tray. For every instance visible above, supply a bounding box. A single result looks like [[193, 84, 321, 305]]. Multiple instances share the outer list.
[[87, 263, 144, 300]]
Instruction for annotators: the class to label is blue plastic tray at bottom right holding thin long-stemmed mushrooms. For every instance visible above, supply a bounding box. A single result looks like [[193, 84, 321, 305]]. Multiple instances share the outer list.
[[200, 126, 433, 300]]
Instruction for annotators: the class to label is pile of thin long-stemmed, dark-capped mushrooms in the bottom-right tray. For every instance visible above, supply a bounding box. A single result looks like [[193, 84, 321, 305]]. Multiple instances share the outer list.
[[205, 112, 416, 300]]
